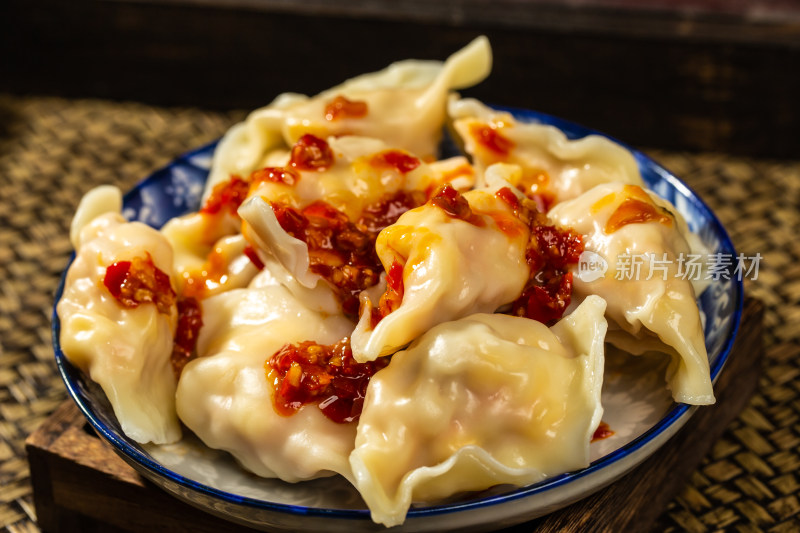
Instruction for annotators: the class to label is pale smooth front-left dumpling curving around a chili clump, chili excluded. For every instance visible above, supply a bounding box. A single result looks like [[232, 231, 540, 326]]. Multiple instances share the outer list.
[[176, 280, 356, 482]]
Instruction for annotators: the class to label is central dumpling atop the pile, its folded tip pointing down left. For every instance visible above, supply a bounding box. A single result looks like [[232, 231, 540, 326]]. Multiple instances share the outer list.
[[351, 181, 530, 361]]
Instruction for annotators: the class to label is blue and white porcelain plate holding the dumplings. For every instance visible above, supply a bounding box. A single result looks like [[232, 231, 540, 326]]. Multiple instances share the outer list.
[[52, 109, 743, 532]]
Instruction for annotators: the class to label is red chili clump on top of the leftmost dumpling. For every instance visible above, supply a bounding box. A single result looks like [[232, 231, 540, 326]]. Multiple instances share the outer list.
[[103, 253, 175, 315]]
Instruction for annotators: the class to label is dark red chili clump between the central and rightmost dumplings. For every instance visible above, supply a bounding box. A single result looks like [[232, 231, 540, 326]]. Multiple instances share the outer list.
[[512, 213, 583, 325]]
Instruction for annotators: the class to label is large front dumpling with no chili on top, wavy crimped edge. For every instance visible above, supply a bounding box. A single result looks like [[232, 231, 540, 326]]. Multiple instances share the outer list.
[[350, 297, 606, 526]]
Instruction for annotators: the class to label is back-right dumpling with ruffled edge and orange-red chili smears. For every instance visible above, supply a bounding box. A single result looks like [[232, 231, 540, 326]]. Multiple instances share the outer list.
[[448, 98, 644, 211]]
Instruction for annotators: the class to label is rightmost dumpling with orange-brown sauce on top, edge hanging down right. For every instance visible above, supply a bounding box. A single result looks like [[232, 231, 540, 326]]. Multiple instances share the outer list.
[[548, 183, 714, 405]]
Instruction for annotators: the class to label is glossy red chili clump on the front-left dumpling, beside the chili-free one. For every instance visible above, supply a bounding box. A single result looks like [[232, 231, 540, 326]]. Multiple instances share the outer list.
[[264, 337, 389, 424]]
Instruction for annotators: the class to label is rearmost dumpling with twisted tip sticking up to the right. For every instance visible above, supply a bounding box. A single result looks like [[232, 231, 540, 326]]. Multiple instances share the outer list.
[[205, 37, 492, 196]]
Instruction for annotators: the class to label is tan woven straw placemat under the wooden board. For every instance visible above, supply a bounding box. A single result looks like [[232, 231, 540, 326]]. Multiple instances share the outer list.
[[0, 95, 800, 532]]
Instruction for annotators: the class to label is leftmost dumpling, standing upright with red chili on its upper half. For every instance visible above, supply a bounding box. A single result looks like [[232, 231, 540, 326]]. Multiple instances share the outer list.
[[57, 188, 181, 444]]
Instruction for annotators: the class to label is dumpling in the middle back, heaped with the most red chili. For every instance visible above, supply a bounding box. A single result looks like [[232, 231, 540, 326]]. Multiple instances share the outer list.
[[239, 135, 474, 316]]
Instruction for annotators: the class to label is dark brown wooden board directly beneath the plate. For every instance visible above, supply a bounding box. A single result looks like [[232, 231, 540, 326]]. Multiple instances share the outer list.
[[26, 300, 763, 533]]
